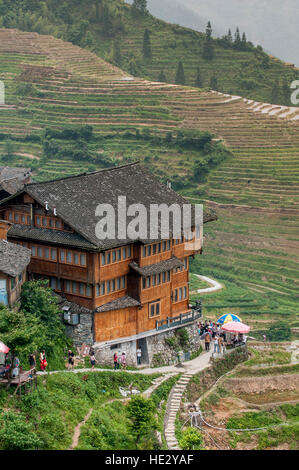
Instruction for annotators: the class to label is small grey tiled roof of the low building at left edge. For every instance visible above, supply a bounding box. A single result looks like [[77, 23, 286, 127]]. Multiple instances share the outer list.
[[0, 240, 31, 277]]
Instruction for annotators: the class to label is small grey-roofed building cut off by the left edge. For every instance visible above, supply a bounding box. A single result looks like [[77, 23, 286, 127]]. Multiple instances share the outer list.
[[0, 220, 31, 307]]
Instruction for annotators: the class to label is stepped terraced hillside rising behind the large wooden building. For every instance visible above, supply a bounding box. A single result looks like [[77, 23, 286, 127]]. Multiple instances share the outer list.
[[0, 29, 299, 329]]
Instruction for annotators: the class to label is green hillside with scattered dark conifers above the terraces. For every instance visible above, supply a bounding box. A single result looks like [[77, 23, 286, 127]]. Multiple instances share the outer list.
[[0, 0, 298, 105]]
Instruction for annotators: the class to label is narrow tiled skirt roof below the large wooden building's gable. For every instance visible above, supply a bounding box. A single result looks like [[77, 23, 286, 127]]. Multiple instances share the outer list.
[[8, 224, 97, 250]]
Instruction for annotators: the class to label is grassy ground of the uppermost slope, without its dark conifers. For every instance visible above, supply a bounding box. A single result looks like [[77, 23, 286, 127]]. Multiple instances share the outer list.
[[0, 0, 298, 105]]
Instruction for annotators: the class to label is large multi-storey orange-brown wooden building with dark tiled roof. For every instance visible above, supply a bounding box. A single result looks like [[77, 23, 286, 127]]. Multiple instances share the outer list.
[[0, 163, 213, 343]]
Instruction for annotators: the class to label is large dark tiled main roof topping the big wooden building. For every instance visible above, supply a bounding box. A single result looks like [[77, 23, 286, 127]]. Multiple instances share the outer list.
[[9, 163, 213, 250]]
